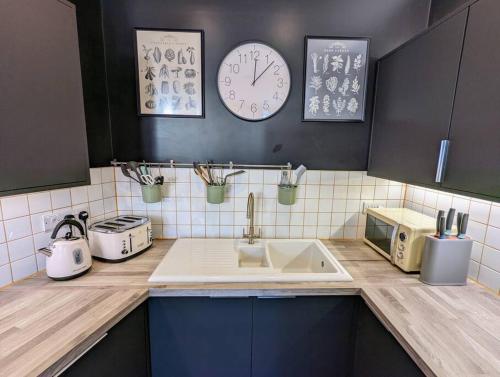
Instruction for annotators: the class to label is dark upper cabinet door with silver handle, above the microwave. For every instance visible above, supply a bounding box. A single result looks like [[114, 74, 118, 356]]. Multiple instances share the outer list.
[[368, 11, 467, 186]]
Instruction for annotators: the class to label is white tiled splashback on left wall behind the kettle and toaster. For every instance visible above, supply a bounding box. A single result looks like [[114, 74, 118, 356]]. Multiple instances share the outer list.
[[0, 167, 116, 286]]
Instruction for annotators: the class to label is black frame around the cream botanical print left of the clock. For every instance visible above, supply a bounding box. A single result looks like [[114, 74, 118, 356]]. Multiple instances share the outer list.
[[133, 27, 205, 119]]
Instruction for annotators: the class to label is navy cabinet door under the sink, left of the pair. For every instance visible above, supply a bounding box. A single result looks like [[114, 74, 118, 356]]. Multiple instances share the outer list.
[[149, 297, 252, 377]]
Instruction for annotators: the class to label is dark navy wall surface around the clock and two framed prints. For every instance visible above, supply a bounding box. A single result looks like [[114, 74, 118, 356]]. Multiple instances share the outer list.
[[74, 0, 430, 170]]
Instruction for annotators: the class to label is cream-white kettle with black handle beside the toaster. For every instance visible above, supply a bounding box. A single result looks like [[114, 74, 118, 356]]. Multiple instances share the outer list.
[[39, 219, 92, 280]]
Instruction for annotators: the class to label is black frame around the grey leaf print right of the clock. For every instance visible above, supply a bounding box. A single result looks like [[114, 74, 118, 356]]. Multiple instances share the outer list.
[[302, 35, 370, 123]]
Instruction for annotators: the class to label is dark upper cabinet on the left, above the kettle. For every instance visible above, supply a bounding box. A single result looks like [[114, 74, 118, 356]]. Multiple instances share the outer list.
[[0, 0, 89, 195]]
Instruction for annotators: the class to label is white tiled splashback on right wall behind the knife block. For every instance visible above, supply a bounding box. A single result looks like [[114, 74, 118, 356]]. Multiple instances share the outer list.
[[404, 185, 500, 292]]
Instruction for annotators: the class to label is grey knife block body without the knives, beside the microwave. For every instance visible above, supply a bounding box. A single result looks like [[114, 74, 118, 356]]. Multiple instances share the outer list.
[[420, 236, 472, 285]]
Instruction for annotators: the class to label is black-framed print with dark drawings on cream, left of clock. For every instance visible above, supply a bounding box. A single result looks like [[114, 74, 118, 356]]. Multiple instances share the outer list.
[[135, 28, 205, 118]]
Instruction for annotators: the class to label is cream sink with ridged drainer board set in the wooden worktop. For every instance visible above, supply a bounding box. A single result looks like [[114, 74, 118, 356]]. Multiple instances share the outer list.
[[149, 238, 352, 283]]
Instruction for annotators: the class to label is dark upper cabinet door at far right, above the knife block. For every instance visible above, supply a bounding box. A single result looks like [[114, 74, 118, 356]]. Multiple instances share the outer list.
[[443, 0, 500, 200]]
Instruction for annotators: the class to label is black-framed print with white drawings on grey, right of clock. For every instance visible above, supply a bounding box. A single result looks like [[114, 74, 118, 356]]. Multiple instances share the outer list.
[[302, 36, 370, 122]]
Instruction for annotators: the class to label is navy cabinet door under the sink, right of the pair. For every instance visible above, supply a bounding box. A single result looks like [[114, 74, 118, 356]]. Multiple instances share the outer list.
[[252, 296, 357, 377]]
